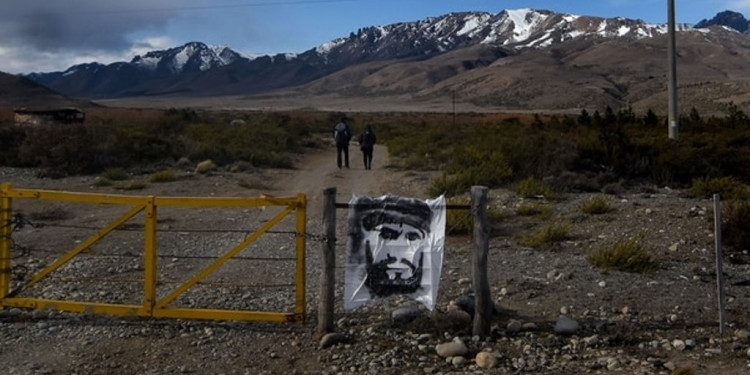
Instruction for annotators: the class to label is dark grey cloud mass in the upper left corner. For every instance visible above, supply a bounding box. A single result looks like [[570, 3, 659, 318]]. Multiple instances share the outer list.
[[0, 0, 188, 52]]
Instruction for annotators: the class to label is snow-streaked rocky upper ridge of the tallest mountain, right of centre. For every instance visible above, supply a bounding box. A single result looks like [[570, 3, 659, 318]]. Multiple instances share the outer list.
[[315, 9, 690, 59]]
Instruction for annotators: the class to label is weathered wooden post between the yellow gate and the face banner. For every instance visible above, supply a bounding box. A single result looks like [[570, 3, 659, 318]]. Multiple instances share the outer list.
[[318, 187, 336, 336]]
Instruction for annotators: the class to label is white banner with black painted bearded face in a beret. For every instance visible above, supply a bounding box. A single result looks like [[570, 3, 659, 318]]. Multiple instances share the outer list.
[[344, 195, 445, 310]]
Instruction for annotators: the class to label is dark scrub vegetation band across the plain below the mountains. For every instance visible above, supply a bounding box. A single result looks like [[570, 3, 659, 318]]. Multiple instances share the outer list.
[[0, 104, 750, 256]]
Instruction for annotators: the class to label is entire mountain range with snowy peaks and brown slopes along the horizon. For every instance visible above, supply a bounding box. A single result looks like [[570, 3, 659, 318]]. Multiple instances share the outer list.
[[13, 9, 750, 113]]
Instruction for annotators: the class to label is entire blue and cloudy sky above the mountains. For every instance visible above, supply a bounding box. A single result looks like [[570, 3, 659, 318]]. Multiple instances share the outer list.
[[0, 0, 750, 74]]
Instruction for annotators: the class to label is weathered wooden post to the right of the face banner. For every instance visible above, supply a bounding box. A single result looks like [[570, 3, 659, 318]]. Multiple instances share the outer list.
[[471, 186, 493, 337]]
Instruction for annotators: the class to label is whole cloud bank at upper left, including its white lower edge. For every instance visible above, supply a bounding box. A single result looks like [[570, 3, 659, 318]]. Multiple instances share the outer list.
[[0, 0, 198, 73]]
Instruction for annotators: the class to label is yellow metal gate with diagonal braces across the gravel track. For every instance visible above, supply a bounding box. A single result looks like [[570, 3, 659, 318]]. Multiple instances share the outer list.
[[0, 184, 307, 322]]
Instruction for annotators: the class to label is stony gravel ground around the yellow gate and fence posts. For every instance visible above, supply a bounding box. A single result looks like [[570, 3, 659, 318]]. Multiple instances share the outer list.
[[0, 159, 750, 375]]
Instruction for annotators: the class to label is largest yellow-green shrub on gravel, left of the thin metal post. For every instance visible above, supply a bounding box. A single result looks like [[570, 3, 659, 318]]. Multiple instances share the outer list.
[[586, 240, 656, 273]]
